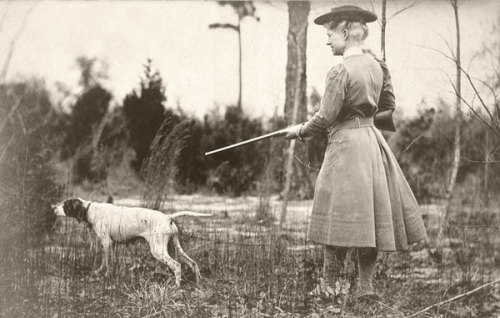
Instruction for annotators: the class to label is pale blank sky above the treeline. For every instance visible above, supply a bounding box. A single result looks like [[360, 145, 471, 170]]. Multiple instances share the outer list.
[[0, 0, 500, 117]]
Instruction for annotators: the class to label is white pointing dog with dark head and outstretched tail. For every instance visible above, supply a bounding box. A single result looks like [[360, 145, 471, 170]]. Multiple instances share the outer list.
[[53, 198, 212, 286]]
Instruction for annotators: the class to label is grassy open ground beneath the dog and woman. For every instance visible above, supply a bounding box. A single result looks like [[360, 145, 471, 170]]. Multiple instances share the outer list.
[[0, 196, 500, 317]]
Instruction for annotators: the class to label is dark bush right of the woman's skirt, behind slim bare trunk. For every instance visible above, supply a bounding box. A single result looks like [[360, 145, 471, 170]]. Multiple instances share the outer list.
[[390, 104, 500, 203]]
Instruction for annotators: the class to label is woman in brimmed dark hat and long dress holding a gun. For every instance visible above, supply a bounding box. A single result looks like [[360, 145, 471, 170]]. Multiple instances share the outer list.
[[286, 6, 426, 298]]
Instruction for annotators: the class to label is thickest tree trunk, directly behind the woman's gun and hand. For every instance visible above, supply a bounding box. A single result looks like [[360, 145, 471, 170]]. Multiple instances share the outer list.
[[280, 1, 310, 225]]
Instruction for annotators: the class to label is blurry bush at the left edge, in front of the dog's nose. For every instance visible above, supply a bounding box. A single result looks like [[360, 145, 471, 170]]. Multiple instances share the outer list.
[[0, 81, 61, 245]]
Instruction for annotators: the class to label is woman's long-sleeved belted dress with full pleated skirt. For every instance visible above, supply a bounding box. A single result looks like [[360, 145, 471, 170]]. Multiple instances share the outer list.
[[303, 48, 426, 251]]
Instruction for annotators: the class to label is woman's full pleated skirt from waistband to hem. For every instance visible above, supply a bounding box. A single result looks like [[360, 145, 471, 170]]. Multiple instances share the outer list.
[[309, 126, 427, 251]]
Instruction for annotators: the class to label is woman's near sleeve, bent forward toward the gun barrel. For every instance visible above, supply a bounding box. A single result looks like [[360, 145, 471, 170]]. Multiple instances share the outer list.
[[300, 64, 349, 137]]
